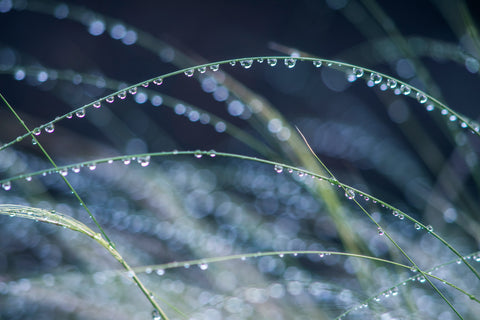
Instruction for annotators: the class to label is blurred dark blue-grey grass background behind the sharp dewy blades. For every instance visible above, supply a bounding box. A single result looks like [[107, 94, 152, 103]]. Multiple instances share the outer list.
[[0, 0, 480, 320]]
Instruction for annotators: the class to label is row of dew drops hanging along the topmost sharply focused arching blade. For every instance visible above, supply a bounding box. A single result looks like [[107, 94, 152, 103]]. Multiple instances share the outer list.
[[20, 57, 480, 148]]
